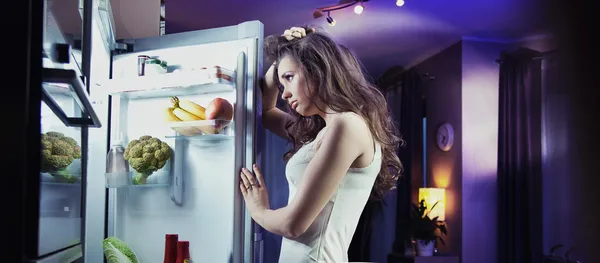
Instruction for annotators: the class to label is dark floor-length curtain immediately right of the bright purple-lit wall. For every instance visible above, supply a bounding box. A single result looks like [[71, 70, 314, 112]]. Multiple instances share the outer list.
[[498, 49, 542, 263]]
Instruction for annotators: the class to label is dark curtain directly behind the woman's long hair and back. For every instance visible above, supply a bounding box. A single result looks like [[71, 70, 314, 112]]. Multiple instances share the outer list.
[[348, 67, 425, 262]]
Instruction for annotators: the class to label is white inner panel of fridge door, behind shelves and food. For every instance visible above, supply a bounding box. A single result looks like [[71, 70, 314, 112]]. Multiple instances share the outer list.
[[109, 38, 250, 262]]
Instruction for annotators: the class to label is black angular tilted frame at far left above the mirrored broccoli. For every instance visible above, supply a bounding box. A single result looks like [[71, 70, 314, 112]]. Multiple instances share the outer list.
[[42, 68, 102, 128]]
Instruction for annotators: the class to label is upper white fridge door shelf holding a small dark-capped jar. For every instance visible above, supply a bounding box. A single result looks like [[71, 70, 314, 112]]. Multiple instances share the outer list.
[[101, 67, 235, 99]]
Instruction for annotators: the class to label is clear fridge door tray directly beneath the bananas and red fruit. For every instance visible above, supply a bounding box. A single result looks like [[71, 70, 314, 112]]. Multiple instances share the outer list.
[[167, 119, 233, 137]]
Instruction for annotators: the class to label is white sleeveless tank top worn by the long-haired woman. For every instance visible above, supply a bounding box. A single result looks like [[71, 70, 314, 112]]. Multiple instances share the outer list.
[[279, 127, 381, 263]]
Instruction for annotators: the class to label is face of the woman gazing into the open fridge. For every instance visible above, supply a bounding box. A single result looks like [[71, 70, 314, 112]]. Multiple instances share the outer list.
[[277, 56, 319, 116]]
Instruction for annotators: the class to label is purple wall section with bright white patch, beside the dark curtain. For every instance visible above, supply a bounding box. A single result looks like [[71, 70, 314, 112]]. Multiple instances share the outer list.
[[461, 40, 508, 263]]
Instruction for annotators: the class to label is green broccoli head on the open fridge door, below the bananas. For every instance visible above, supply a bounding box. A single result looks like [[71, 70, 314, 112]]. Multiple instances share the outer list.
[[123, 135, 172, 185]]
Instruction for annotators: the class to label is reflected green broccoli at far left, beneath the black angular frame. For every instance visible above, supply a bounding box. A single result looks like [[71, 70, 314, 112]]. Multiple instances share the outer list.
[[41, 131, 81, 183]]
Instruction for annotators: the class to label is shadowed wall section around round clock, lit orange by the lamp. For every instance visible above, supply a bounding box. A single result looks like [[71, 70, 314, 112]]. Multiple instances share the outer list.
[[412, 42, 463, 255]]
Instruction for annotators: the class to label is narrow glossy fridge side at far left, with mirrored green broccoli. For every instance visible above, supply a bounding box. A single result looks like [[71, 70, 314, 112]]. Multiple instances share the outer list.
[[36, 0, 106, 262]]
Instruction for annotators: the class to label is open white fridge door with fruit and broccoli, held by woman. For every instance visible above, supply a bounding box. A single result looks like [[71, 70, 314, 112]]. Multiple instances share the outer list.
[[86, 21, 263, 262]]
